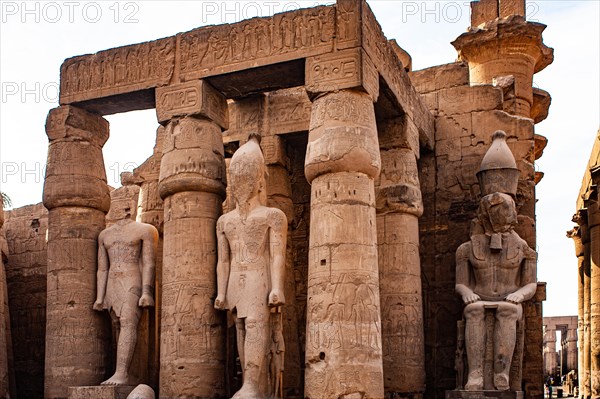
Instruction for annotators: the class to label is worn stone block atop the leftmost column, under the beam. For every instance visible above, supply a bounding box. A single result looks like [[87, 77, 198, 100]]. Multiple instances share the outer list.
[[46, 105, 109, 147]]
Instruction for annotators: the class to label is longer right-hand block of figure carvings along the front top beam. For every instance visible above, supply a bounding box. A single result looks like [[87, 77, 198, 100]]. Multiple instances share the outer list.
[[180, 7, 335, 81]]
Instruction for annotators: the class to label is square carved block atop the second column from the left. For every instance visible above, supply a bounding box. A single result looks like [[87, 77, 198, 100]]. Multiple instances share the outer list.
[[156, 80, 229, 129]]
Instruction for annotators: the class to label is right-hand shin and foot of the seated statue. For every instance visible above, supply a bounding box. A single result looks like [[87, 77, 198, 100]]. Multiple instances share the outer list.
[[494, 302, 523, 391]]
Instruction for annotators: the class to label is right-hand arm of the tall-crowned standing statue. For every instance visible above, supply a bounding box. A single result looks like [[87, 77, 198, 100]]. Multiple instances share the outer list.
[[269, 209, 287, 306]]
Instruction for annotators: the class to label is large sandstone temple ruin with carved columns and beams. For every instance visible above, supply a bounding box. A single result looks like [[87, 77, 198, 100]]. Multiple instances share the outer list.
[[0, 0, 553, 399]]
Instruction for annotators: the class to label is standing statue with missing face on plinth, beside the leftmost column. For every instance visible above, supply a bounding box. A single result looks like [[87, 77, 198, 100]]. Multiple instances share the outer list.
[[94, 187, 158, 385]]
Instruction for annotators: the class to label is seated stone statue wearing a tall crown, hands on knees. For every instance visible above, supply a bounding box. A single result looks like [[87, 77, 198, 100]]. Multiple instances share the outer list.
[[456, 131, 537, 391]]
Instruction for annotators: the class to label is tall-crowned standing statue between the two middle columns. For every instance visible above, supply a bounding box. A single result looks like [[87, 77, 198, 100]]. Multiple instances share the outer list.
[[215, 134, 287, 399]]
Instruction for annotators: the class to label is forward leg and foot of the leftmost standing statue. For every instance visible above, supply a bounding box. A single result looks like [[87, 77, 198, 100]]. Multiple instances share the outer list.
[[102, 295, 142, 385]]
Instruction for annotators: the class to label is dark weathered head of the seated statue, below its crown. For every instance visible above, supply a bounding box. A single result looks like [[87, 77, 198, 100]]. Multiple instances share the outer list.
[[478, 193, 517, 234]]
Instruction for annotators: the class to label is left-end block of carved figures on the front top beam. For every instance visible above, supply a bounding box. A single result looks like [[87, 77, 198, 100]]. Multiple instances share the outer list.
[[60, 37, 175, 104]]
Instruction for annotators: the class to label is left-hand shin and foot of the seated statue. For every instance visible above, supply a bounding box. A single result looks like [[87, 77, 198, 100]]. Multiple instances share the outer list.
[[464, 302, 485, 391]]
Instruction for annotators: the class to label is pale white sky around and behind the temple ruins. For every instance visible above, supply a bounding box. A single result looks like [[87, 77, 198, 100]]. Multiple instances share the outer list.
[[0, 0, 600, 316]]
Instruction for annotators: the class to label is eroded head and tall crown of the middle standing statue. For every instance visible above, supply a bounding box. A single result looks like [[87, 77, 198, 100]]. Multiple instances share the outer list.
[[229, 133, 265, 217]]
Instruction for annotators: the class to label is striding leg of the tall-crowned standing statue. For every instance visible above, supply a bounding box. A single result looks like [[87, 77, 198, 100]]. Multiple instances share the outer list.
[[233, 306, 271, 399]]
